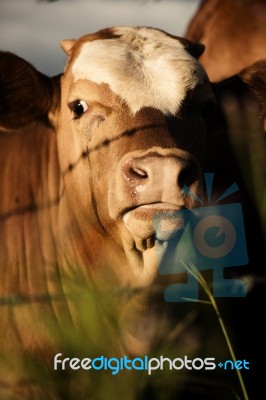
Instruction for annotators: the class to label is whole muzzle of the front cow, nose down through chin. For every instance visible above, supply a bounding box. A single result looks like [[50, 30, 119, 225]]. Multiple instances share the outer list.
[[108, 148, 202, 247]]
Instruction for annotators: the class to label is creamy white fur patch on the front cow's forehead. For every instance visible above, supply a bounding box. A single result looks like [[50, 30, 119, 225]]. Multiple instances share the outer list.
[[72, 27, 206, 114]]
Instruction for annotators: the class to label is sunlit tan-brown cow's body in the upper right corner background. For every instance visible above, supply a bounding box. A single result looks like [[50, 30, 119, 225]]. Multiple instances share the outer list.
[[184, 0, 266, 82]]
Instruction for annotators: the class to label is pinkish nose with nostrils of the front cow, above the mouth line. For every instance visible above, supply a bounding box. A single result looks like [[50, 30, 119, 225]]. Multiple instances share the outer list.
[[122, 153, 200, 204]]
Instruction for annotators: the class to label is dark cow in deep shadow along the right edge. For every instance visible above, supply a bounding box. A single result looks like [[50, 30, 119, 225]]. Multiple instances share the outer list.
[[200, 59, 266, 398]]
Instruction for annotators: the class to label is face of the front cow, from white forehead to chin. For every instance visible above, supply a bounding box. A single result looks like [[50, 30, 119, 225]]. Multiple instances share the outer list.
[[58, 27, 213, 284]]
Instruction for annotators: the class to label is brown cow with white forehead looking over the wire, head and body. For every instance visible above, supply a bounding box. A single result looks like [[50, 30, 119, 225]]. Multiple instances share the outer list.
[[0, 26, 214, 400]]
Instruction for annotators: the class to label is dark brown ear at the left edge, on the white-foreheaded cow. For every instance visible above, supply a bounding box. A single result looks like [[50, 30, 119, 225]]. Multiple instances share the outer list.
[[0, 52, 60, 129]]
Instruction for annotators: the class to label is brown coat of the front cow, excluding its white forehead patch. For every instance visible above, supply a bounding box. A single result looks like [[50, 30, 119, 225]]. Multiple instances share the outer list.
[[0, 26, 213, 400]]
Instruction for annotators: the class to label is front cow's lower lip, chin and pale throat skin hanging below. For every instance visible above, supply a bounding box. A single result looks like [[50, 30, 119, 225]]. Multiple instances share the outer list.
[[116, 202, 184, 293]]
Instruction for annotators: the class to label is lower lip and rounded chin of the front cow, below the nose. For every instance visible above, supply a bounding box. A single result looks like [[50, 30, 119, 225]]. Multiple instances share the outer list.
[[122, 203, 184, 251]]
